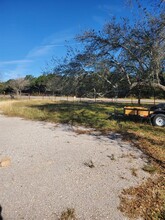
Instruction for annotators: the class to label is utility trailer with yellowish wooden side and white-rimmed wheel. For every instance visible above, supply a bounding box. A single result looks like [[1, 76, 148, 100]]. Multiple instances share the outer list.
[[124, 103, 165, 127]]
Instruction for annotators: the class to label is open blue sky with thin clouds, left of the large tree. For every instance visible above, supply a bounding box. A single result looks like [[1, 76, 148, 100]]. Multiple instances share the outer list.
[[0, 0, 130, 80]]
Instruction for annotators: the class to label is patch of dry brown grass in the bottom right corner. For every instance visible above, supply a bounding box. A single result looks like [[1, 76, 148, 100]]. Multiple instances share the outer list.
[[120, 175, 165, 220]]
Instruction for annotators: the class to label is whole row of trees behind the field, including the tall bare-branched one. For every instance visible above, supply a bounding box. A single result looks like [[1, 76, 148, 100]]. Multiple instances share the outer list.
[[0, 0, 165, 98]]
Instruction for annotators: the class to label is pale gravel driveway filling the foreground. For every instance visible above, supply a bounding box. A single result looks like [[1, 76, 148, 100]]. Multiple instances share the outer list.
[[0, 115, 149, 220]]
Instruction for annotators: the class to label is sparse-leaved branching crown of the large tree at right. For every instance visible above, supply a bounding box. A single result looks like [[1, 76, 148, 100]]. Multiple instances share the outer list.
[[77, 0, 165, 94]]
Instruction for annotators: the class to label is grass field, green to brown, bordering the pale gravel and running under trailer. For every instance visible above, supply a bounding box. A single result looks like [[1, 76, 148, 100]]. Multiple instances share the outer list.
[[0, 100, 165, 219]]
